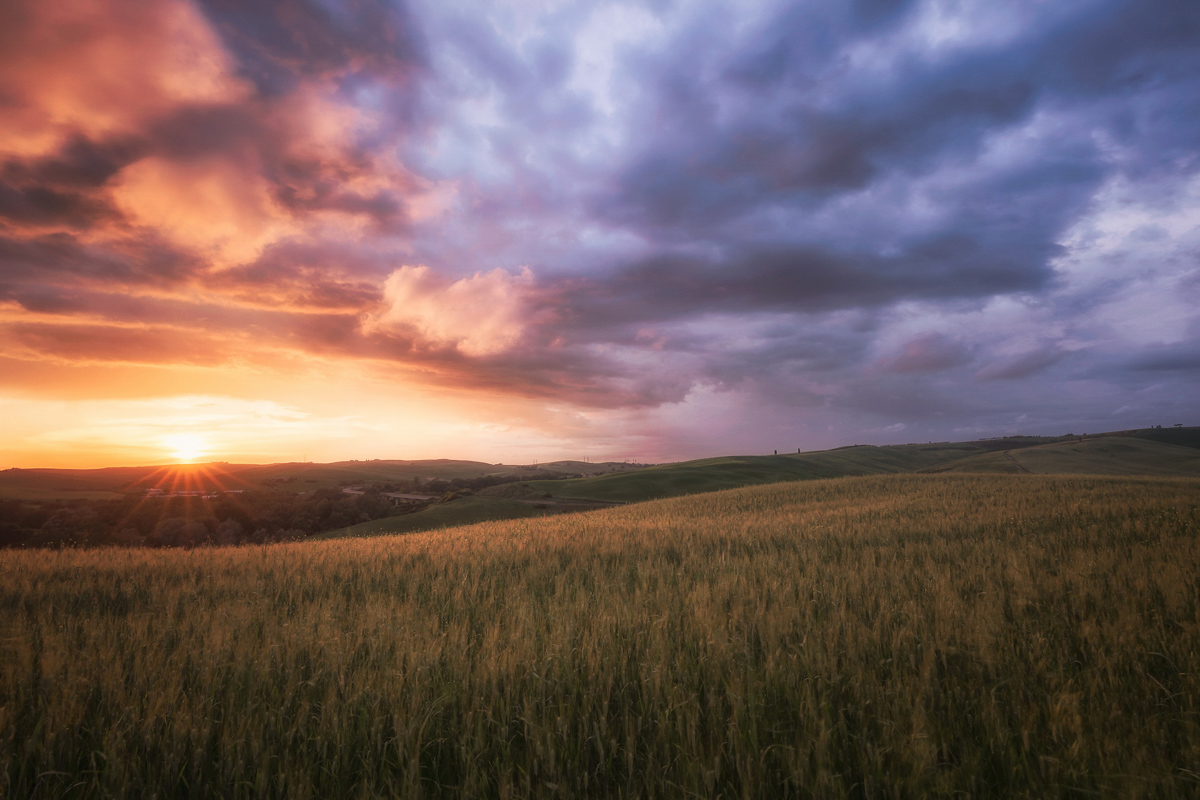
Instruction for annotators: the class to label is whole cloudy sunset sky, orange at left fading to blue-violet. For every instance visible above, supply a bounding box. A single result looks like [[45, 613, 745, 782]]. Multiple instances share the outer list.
[[0, 0, 1200, 468]]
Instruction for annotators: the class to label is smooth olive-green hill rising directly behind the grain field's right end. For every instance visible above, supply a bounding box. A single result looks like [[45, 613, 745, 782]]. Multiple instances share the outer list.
[[924, 437, 1200, 476]]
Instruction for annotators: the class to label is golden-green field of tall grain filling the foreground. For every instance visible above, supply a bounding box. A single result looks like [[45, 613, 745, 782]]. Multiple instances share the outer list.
[[0, 475, 1200, 799]]
